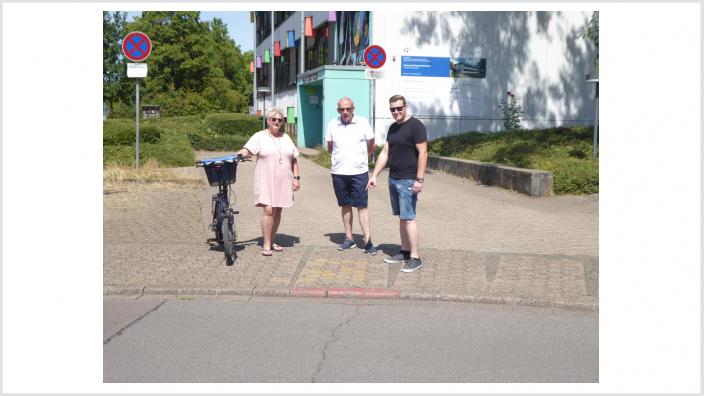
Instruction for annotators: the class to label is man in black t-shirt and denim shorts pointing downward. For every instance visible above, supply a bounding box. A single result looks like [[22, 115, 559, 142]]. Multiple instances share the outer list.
[[367, 95, 428, 272]]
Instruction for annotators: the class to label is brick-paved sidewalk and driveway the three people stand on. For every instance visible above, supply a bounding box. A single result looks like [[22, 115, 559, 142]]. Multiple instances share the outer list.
[[103, 153, 599, 310]]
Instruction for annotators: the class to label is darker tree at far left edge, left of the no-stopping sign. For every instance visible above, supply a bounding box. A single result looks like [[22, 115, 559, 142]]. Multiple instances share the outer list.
[[103, 11, 133, 113]]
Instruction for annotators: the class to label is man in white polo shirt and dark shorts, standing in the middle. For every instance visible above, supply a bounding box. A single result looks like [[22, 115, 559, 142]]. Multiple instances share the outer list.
[[325, 97, 377, 254]]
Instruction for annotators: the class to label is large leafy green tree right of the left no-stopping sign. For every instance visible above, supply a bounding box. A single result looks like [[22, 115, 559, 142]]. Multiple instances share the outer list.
[[118, 11, 252, 115]]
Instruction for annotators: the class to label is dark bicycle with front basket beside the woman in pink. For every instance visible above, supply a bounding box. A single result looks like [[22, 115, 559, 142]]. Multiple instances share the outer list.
[[196, 155, 249, 265]]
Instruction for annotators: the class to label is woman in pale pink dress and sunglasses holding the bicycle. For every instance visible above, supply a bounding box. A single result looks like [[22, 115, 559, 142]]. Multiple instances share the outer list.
[[237, 108, 301, 256]]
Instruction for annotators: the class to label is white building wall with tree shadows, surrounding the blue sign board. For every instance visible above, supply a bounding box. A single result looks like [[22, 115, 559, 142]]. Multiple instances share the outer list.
[[372, 11, 595, 139]]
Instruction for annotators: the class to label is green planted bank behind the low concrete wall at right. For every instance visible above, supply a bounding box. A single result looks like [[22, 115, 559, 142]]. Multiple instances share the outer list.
[[428, 126, 599, 195]]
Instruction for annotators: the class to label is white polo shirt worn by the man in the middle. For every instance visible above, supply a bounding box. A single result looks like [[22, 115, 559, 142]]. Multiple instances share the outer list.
[[323, 114, 374, 175]]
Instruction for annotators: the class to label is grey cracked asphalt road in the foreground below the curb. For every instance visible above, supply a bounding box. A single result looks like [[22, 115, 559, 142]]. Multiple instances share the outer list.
[[103, 296, 599, 383]]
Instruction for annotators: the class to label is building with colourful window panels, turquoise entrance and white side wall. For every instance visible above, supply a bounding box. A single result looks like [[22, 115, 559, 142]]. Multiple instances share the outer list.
[[252, 11, 596, 147]]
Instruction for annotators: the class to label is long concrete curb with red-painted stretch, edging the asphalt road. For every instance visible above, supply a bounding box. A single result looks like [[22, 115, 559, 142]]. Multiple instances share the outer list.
[[103, 286, 599, 312]]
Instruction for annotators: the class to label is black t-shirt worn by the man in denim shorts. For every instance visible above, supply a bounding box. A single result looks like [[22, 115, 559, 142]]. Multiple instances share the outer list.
[[386, 117, 428, 179]]
